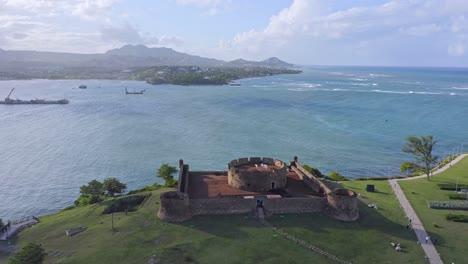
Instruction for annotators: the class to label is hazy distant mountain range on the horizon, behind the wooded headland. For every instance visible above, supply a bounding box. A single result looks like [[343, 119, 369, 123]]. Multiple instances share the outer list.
[[0, 45, 294, 73]]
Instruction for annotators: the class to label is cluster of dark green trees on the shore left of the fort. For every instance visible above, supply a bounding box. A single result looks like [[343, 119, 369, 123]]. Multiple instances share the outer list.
[[75, 177, 127, 205]]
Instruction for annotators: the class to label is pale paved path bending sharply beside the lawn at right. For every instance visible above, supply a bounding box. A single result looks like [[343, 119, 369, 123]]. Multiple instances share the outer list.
[[388, 154, 468, 264]]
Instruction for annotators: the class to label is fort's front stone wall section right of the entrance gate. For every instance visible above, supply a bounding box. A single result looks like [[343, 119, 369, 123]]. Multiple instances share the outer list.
[[263, 197, 327, 214]]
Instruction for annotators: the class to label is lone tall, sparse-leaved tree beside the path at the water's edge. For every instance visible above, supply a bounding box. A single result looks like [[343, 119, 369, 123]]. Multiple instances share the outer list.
[[403, 135, 437, 180]]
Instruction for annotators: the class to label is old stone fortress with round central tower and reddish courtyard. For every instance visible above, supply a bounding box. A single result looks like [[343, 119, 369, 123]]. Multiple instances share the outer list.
[[158, 157, 359, 222]]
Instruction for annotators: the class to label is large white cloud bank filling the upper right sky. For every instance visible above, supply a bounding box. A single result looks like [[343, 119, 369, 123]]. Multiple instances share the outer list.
[[217, 0, 468, 61]]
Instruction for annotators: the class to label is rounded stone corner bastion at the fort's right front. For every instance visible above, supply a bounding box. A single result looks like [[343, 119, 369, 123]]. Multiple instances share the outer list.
[[326, 189, 359, 221]]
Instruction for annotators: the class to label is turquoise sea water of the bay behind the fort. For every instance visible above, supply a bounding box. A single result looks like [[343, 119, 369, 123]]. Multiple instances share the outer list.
[[0, 67, 468, 219]]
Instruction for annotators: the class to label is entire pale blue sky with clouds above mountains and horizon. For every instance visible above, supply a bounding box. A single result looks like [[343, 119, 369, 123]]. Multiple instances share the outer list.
[[0, 0, 468, 67]]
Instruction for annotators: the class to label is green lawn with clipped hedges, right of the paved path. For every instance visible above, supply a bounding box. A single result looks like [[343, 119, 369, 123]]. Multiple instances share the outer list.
[[399, 158, 468, 263]]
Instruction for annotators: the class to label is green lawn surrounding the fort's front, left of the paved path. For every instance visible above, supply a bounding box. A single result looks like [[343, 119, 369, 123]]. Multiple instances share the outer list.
[[4, 181, 424, 263]]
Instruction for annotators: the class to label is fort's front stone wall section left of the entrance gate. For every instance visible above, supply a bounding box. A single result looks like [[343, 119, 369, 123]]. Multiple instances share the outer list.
[[190, 198, 256, 215]]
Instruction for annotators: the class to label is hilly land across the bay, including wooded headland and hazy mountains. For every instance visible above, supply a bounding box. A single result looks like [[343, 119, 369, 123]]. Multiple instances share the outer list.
[[0, 45, 301, 85]]
